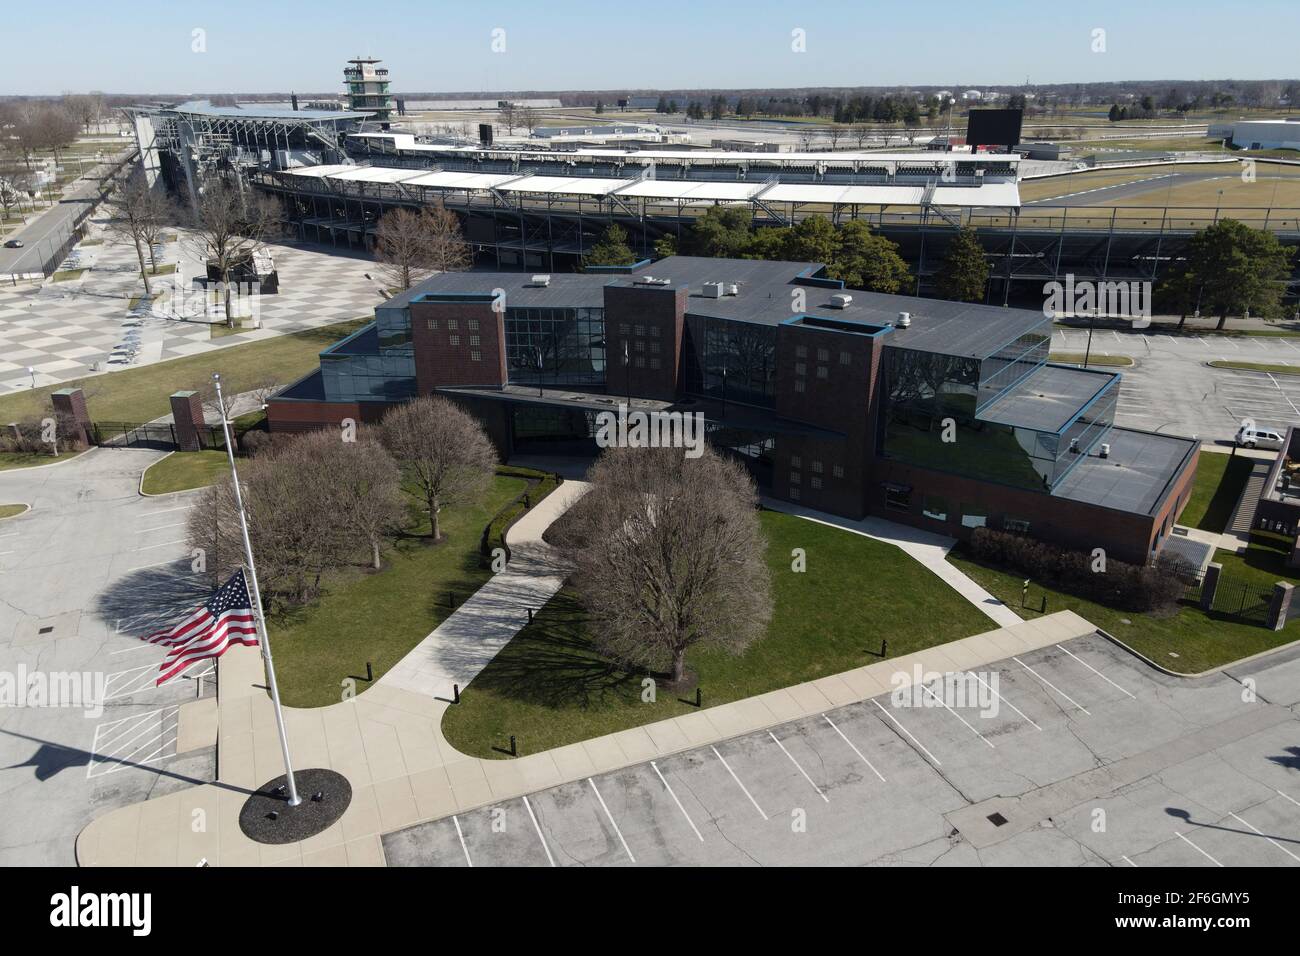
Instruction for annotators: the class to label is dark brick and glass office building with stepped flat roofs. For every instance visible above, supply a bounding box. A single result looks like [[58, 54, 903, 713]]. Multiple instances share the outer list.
[[268, 256, 1197, 562]]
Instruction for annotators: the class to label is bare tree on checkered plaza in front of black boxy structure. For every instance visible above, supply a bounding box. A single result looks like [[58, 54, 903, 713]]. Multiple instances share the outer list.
[[191, 179, 282, 329]]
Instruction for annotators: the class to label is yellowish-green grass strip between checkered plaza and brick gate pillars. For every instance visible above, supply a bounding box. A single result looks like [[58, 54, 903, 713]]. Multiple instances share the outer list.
[[0, 317, 372, 421]]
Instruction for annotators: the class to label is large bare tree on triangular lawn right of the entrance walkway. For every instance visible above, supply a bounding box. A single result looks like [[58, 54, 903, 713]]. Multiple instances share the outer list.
[[556, 449, 772, 687]]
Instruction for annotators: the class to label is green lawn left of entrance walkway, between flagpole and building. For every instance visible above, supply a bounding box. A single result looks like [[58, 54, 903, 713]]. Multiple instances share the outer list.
[[269, 475, 528, 708]]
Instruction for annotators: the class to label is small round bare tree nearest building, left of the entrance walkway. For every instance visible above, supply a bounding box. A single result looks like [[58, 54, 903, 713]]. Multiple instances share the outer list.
[[380, 395, 497, 541]]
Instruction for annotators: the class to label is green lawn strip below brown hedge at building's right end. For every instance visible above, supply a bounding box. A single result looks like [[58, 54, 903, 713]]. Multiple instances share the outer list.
[[948, 551, 1300, 674]]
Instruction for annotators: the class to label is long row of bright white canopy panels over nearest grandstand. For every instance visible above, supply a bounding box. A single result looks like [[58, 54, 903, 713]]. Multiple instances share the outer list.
[[285, 165, 1021, 208]]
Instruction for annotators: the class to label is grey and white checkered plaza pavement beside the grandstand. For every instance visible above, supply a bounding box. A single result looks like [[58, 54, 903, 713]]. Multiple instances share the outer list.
[[0, 233, 381, 394]]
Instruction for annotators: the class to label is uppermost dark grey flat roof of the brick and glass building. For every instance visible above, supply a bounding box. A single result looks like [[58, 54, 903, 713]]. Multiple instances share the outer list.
[[385, 256, 1048, 359]]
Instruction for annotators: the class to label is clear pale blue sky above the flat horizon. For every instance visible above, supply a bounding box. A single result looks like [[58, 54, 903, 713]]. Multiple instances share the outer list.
[[10, 0, 1300, 94]]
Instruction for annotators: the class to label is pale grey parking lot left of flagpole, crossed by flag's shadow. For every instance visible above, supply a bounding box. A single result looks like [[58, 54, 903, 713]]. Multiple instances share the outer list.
[[0, 449, 216, 866]]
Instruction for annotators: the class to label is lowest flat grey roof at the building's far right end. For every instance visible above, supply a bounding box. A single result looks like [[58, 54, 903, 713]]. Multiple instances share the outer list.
[[1052, 428, 1197, 515]]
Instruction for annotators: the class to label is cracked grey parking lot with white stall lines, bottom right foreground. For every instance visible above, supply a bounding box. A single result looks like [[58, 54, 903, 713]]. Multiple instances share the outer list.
[[384, 636, 1300, 866]]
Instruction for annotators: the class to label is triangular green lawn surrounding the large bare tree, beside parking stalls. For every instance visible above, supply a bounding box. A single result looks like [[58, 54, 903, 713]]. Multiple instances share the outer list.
[[442, 511, 993, 758]]
